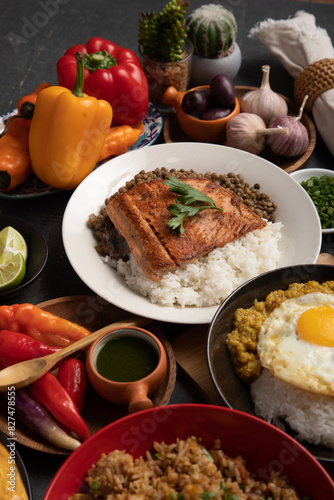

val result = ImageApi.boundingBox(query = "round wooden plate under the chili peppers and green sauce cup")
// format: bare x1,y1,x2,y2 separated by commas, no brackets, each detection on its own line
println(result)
0,295,176,455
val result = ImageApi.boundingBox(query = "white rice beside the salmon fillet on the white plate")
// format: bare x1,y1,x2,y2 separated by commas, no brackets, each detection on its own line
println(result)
110,222,283,307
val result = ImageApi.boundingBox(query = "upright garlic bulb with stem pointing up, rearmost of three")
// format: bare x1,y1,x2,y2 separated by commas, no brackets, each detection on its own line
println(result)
240,65,288,125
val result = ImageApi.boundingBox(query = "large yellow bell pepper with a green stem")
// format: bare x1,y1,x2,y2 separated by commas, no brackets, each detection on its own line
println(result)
29,52,113,189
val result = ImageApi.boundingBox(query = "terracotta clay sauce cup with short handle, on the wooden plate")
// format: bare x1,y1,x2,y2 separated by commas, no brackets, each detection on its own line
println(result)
86,327,167,413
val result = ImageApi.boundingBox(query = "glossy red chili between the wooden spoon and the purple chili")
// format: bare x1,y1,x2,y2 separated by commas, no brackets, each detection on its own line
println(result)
29,372,90,440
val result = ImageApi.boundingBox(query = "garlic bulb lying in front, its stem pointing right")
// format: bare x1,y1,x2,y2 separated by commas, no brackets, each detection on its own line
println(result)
226,113,289,155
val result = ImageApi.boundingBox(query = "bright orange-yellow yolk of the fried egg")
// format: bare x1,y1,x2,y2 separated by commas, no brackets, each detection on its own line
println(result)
297,306,334,347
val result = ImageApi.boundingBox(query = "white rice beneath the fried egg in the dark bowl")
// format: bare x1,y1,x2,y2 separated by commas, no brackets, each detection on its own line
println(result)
251,369,334,448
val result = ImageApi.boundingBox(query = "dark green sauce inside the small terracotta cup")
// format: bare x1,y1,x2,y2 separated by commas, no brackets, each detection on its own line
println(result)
96,335,159,382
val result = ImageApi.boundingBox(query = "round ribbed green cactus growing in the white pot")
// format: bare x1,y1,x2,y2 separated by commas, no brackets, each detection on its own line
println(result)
186,4,237,58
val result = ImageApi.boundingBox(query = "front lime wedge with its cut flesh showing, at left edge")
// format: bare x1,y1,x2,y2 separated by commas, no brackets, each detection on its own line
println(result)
0,250,26,292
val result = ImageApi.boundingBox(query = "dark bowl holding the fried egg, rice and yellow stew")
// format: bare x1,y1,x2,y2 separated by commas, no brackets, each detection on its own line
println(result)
207,265,334,461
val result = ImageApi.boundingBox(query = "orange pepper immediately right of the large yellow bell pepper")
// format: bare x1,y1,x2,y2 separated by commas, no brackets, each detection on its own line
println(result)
99,122,144,161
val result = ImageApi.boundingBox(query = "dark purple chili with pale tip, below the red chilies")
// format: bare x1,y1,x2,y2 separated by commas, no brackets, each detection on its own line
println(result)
11,387,81,451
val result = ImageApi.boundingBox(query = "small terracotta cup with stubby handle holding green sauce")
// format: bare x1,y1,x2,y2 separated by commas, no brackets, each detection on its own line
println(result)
86,327,167,413
